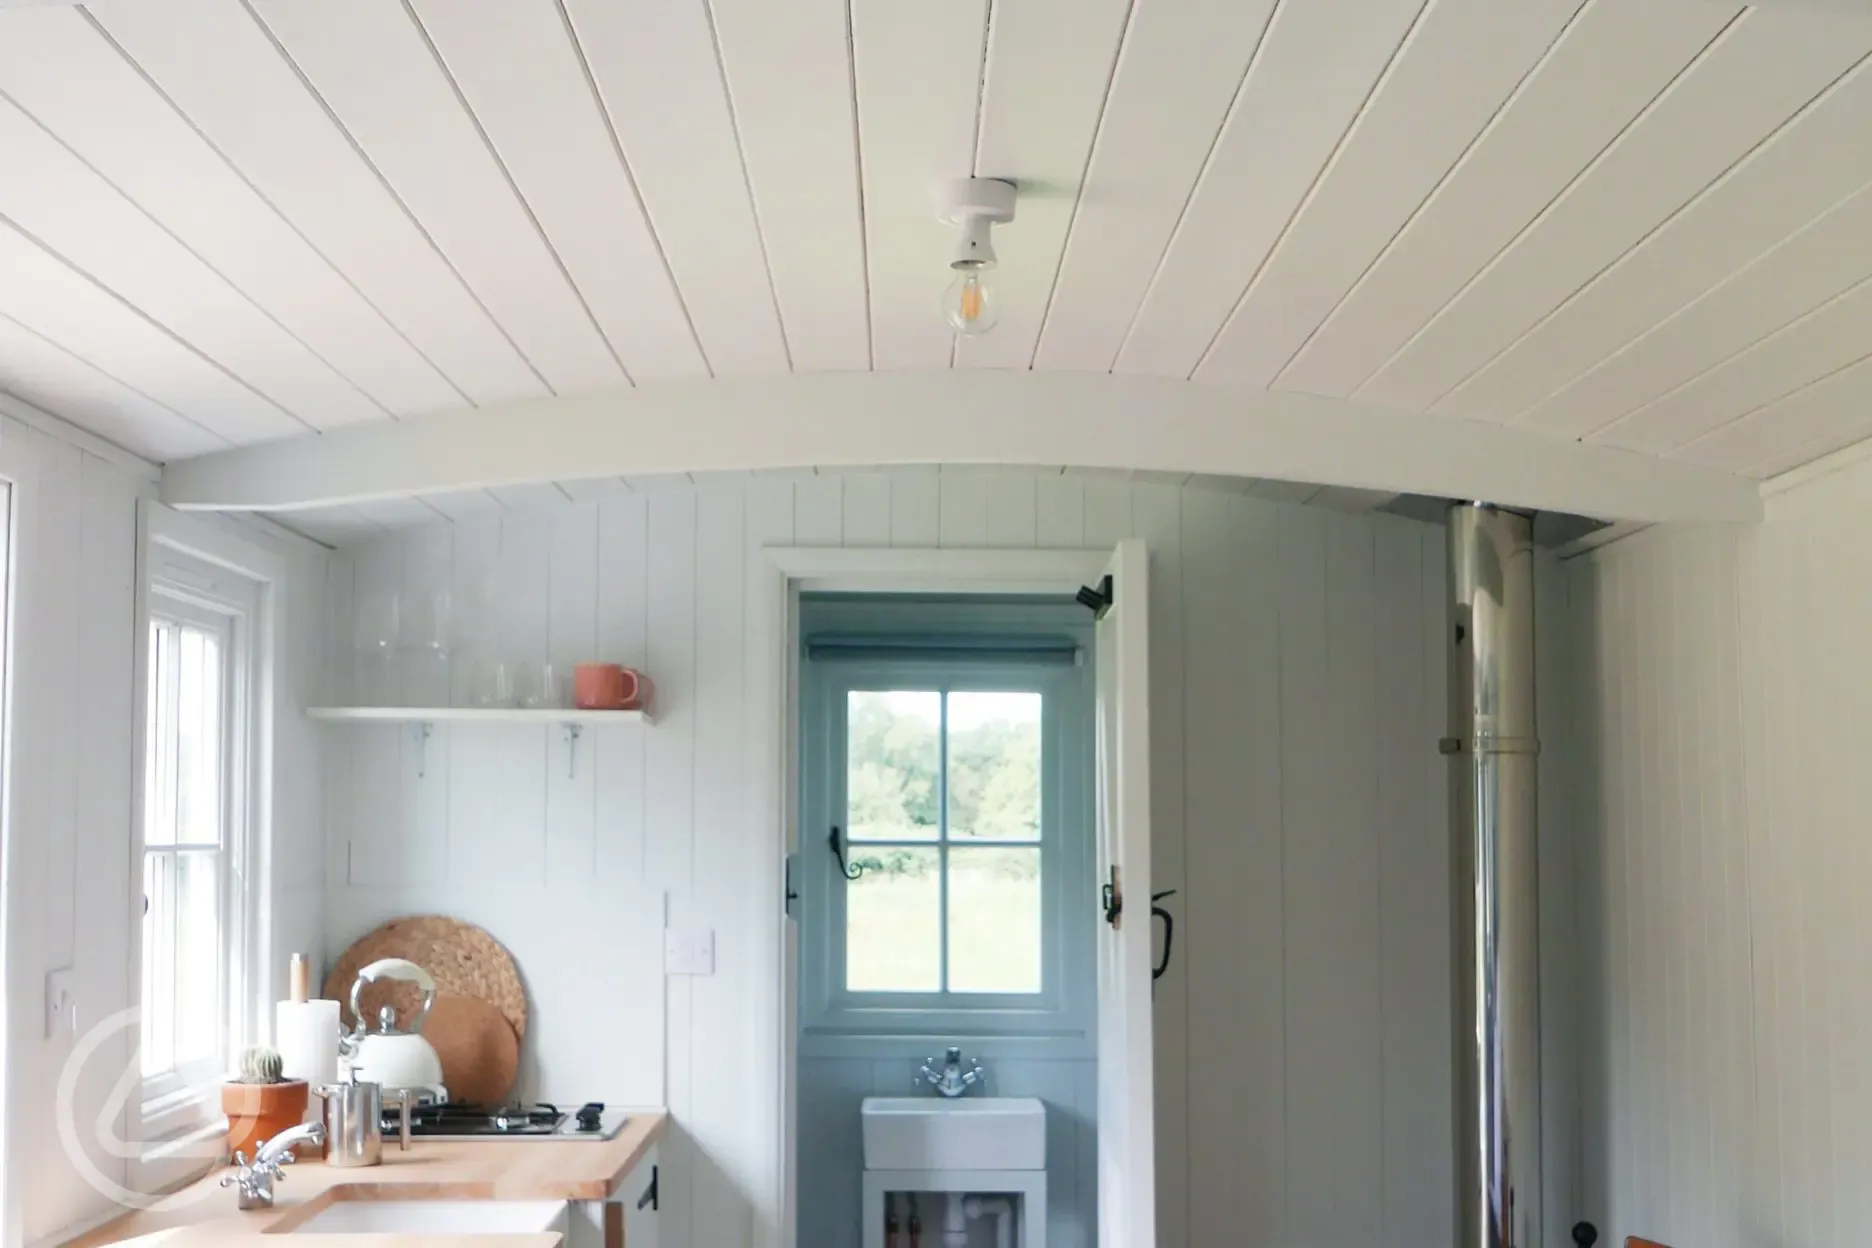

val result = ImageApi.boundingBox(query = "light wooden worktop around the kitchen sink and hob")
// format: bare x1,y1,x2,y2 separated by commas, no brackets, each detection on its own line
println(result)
67,1111,666,1248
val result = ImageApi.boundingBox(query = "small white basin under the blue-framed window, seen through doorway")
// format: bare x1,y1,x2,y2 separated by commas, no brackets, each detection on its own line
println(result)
861,1096,1046,1169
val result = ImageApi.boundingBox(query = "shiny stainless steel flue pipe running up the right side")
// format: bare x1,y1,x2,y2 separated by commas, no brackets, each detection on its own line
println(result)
1441,503,1541,1248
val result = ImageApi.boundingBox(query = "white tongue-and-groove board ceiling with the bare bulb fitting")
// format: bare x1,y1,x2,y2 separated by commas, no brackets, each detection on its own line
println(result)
0,0,1872,501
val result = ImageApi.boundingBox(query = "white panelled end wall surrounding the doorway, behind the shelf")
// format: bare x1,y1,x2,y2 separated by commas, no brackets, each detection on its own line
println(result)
326,468,1571,1248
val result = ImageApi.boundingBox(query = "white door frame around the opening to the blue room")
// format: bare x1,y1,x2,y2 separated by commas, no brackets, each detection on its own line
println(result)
747,546,1112,1248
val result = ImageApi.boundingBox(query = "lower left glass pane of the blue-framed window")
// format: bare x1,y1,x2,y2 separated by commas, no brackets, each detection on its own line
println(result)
844,846,942,992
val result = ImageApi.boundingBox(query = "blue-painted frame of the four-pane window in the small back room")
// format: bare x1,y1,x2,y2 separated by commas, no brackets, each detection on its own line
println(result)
796,649,1095,1055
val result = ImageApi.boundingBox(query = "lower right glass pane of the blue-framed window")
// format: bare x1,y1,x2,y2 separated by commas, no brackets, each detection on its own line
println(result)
949,848,1041,992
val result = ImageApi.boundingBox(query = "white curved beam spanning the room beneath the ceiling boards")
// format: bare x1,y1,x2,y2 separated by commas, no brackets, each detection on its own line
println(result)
163,370,1762,522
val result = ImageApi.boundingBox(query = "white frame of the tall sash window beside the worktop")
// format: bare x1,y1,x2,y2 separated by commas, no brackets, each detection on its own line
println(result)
125,531,270,1145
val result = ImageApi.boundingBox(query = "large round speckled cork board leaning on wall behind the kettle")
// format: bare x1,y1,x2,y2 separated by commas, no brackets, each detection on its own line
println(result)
324,915,526,1037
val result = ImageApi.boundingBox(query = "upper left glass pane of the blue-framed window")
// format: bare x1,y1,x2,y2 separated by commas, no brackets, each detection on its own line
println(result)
844,690,942,840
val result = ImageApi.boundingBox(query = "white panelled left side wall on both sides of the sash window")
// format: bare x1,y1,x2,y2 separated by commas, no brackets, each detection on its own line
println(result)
0,404,326,1242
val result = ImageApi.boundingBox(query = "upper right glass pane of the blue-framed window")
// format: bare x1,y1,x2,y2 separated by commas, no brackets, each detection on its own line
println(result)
949,692,1041,840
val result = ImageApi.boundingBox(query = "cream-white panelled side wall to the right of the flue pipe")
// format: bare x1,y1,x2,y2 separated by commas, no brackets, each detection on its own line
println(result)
1543,450,1872,1246
